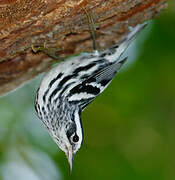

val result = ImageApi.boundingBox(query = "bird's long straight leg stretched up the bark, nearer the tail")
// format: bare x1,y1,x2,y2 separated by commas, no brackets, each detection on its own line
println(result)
83,8,97,51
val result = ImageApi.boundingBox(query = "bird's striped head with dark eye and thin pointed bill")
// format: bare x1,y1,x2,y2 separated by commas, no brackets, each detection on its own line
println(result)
48,109,83,171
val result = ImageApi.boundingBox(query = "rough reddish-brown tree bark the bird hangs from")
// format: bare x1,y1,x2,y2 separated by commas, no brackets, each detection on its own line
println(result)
0,0,166,95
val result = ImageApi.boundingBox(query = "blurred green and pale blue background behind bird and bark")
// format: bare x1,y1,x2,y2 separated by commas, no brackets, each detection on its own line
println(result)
0,0,175,180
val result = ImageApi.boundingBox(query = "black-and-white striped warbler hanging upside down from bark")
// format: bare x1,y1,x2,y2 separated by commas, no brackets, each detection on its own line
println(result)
35,10,145,169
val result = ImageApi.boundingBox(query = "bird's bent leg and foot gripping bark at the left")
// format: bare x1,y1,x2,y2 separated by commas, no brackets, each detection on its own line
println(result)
31,42,63,60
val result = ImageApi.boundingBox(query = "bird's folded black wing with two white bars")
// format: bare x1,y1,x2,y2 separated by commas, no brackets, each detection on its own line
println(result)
67,58,127,110
